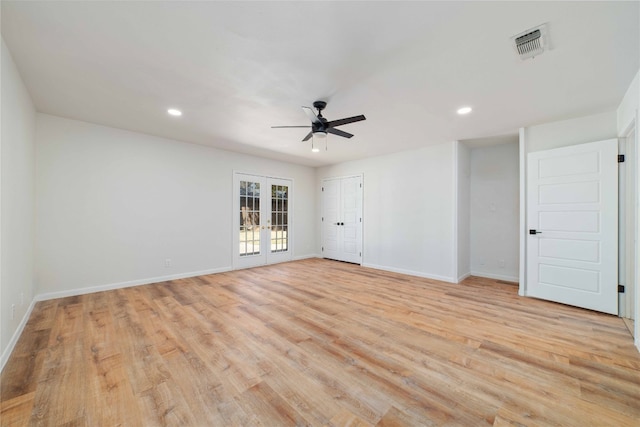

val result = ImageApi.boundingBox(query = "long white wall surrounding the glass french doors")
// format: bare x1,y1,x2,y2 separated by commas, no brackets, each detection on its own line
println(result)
36,114,317,297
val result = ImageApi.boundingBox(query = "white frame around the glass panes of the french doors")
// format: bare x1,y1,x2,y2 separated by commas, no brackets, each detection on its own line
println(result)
231,169,295,270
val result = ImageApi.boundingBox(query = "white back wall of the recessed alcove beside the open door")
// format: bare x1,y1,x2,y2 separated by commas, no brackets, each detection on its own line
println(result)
470,141,520,282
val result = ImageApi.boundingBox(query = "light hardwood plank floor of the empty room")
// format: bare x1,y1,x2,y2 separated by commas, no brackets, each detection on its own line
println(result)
1,259,640,427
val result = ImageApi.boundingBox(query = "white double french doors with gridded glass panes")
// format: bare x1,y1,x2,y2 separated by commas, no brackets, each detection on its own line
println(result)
233,173,292,269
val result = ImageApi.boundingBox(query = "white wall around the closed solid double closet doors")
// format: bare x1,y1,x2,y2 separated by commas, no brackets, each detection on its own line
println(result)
316,142,457,282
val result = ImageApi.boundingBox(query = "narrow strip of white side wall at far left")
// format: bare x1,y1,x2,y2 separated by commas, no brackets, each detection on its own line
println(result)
0,40,36,366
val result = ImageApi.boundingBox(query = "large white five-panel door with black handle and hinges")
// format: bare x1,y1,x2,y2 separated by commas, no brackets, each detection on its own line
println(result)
526,139,618,314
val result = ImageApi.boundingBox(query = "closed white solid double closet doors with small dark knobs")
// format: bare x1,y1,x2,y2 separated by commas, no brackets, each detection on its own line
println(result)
322,176,362,264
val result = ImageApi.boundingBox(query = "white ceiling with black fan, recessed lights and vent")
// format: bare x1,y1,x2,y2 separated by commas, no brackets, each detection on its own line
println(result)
1,0,640,166
